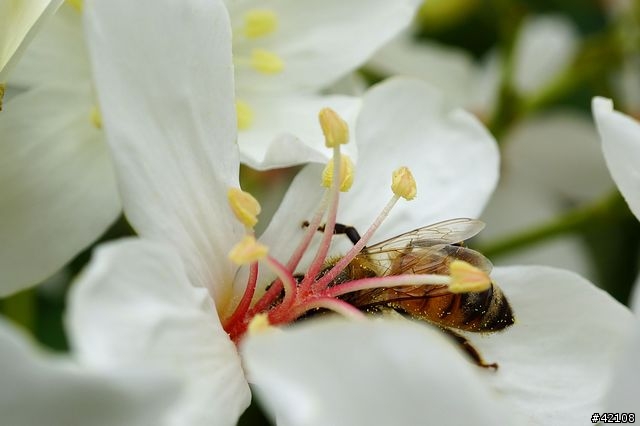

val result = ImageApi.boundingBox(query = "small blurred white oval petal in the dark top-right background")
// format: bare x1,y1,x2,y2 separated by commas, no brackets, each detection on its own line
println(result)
514,15,579,94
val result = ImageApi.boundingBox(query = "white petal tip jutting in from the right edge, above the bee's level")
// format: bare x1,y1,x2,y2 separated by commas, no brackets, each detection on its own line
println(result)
591,97,640,218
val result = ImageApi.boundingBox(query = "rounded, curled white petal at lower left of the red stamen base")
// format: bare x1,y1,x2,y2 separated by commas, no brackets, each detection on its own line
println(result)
68,239,250,425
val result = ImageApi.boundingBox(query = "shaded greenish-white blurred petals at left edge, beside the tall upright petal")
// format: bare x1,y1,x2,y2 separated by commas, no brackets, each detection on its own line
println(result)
0,2,121,296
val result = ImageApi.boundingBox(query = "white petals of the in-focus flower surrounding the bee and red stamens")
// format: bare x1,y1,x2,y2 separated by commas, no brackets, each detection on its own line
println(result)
58,0,631,425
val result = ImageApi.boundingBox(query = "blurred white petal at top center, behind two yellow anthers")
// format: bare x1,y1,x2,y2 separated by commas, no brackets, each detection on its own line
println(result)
231,0,420,94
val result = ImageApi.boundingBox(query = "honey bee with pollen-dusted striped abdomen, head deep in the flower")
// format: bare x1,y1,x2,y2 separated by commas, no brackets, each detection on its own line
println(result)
321,218,514,368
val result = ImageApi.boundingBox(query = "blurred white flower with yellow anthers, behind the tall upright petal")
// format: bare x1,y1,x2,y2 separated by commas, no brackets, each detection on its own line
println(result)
0,0,419,295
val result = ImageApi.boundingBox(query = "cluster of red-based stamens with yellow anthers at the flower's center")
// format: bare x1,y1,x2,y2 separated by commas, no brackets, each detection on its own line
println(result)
222,111,491,342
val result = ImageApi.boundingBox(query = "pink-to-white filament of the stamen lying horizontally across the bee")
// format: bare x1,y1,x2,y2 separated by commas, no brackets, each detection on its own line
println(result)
324,274,452,297
